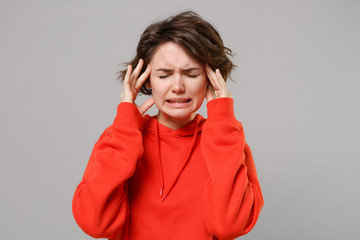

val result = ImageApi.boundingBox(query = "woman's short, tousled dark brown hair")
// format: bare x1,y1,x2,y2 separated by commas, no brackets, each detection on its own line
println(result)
118,11,235,95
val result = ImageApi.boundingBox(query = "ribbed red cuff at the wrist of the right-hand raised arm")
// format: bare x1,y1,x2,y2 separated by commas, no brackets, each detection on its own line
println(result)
206,97,236,121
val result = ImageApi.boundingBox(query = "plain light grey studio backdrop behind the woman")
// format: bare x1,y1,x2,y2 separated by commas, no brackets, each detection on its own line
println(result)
0,0,360,240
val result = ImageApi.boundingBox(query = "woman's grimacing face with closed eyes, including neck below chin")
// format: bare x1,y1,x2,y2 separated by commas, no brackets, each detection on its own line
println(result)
150,42,207,129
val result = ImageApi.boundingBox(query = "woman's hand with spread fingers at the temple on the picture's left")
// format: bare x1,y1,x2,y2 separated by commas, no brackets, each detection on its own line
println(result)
121,59,154,115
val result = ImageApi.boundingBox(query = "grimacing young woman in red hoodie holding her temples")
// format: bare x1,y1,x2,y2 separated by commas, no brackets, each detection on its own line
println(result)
73,12,263,240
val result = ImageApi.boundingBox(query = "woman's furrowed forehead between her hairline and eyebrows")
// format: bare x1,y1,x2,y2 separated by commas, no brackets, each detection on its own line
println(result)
150,42,203,69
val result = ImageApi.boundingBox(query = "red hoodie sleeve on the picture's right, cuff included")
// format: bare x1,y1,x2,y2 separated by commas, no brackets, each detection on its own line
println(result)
201,98,264,239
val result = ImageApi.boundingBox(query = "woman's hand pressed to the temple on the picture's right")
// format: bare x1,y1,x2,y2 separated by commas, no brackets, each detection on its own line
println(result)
205,64,231,102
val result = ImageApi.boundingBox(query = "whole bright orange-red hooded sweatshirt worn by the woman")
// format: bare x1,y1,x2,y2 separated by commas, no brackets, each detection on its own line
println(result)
72,98,263,240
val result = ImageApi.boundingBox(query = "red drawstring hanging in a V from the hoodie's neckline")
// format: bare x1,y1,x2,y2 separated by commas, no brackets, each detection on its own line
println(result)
155,119,199,201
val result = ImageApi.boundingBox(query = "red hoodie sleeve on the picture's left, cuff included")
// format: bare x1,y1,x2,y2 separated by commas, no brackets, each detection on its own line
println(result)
72,103,143,238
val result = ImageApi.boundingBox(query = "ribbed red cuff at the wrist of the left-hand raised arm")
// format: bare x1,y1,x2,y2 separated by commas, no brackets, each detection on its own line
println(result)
114,102,142,129
